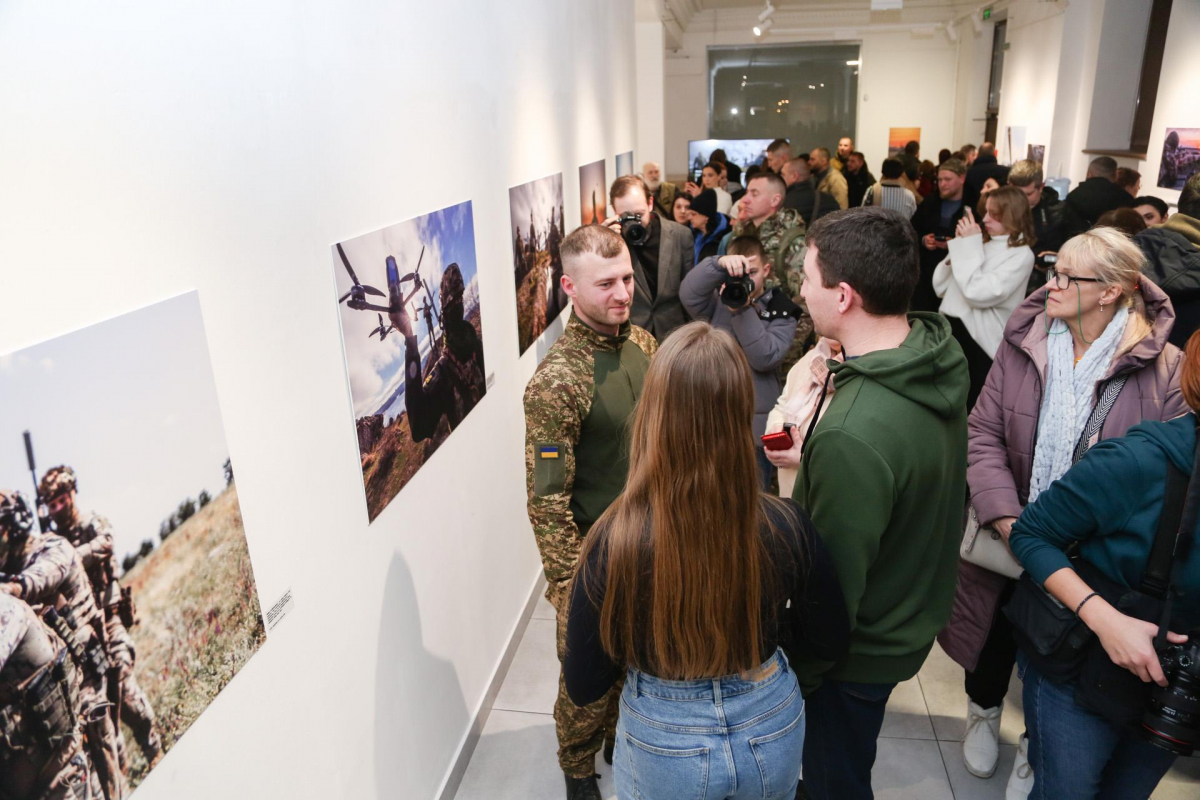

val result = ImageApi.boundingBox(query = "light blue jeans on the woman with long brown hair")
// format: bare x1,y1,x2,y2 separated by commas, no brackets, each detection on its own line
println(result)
612,650,804,800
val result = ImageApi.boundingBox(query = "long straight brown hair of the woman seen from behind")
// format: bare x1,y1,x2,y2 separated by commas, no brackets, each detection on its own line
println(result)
575,321,787,680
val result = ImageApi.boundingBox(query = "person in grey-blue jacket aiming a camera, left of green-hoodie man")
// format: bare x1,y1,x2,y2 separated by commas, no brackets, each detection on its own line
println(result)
679,236,802,489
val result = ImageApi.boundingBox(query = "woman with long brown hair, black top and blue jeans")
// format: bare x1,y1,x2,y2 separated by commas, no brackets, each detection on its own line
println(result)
563,323,850,800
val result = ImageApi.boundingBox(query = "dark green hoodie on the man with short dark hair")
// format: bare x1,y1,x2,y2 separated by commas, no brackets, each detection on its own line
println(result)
788,313,970,691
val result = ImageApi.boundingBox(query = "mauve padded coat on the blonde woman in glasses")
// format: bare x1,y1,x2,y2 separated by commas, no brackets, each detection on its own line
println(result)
937,277,1188,670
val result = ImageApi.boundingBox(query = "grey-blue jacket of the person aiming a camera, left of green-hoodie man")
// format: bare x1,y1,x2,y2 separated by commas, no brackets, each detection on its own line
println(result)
679,257,799,437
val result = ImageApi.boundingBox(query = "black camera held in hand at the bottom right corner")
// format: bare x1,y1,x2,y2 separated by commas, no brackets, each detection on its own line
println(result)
1141,639,1200,756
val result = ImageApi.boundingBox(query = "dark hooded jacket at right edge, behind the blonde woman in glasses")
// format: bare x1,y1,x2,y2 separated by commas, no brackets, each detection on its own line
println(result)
1133,213,1200,349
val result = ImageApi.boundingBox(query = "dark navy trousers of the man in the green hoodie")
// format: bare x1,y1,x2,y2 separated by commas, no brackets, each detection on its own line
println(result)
804,678,896,800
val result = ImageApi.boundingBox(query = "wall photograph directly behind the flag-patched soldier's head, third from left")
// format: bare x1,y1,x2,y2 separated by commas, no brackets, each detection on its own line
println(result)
509,173,566,354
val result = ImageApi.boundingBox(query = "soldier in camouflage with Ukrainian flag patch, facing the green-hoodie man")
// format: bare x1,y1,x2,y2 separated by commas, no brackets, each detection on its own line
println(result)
524,225,658,800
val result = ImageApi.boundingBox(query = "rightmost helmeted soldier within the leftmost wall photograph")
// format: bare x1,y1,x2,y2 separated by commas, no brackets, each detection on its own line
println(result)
38,467,162,772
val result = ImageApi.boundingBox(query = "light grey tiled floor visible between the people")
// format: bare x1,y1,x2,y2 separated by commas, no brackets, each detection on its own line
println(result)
456,600,1200,800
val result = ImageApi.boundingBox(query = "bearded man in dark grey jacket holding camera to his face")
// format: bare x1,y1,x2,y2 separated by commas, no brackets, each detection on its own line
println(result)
604,175,695,342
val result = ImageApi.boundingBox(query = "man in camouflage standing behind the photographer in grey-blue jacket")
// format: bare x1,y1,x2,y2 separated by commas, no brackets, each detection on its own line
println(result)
731,175,812,375
